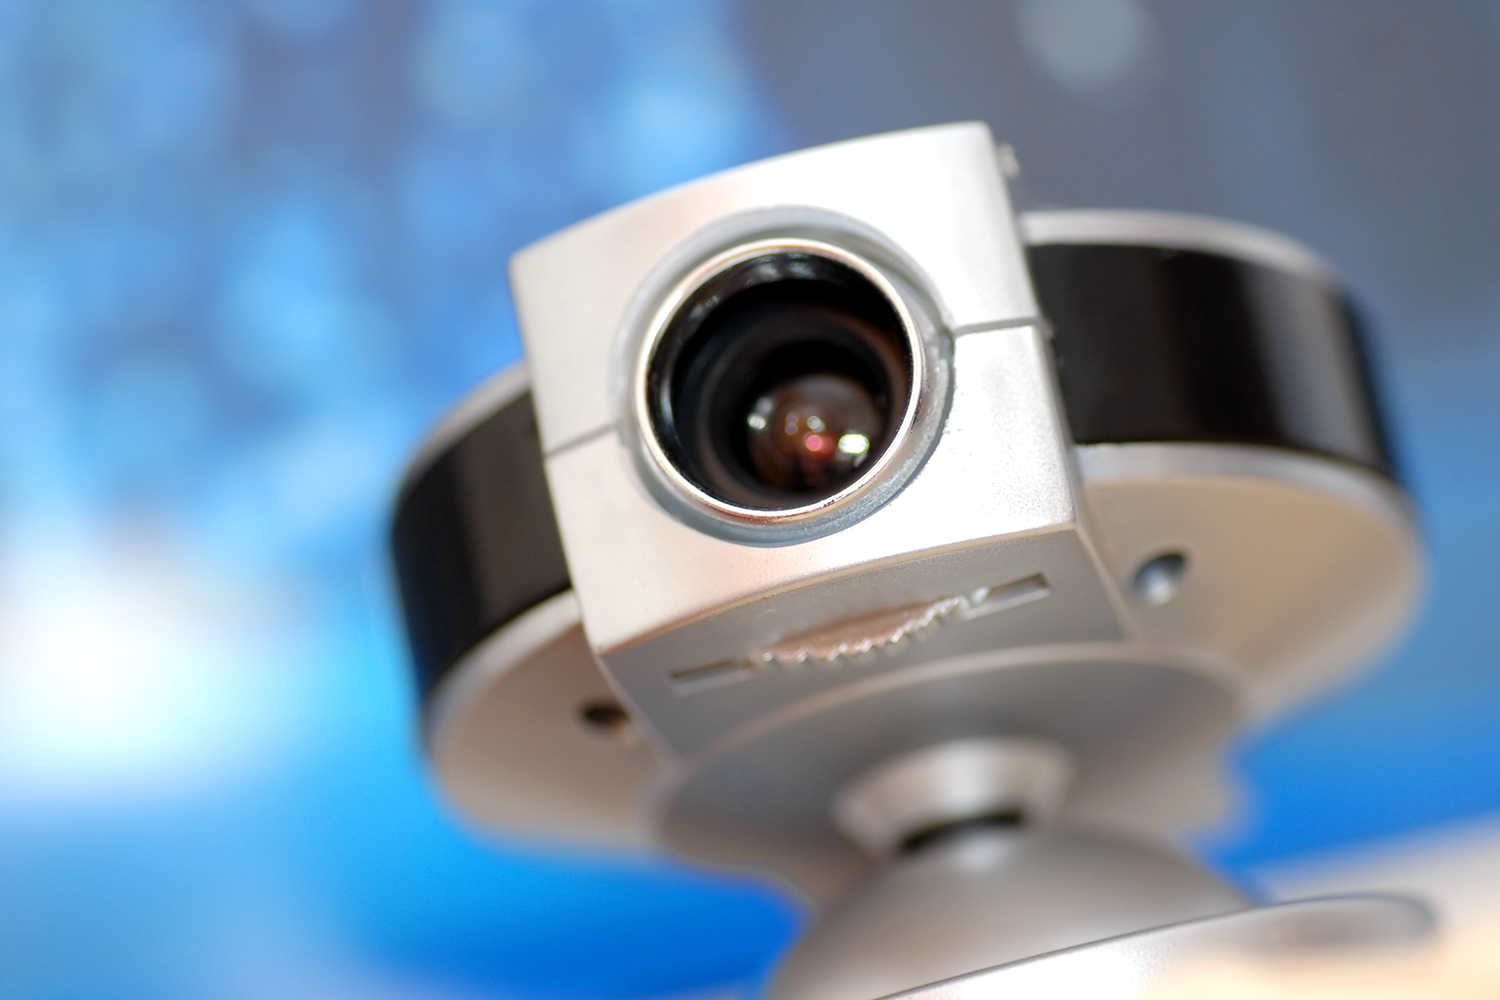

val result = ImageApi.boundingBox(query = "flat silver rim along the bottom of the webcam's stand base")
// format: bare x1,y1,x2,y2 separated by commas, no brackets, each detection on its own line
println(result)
893,895,1434,1000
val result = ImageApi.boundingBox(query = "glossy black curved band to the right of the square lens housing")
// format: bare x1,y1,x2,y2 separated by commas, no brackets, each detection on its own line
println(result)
1028,244,1394,475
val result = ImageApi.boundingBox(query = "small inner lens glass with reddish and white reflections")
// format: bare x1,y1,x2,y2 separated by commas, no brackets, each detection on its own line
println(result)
746,373,885,493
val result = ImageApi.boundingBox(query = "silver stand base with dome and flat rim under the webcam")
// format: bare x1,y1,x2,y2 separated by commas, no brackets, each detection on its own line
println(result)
771,826,1431,1000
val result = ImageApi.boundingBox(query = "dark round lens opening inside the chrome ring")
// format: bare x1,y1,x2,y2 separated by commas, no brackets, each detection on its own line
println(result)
647,249,915,511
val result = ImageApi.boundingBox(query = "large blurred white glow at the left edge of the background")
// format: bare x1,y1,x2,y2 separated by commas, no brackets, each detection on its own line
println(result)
0,521,296,799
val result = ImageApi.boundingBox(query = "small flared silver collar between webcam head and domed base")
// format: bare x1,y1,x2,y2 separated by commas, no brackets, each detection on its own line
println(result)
831,736,1074,858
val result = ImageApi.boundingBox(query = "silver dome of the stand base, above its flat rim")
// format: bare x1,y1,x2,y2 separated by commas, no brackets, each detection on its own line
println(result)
771,829,1250,1000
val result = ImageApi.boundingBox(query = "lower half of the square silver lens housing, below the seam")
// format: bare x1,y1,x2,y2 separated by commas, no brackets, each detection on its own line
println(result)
548,327,1104,756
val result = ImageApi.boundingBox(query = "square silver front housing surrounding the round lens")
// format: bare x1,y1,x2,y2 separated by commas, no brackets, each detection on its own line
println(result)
513,126,1122,756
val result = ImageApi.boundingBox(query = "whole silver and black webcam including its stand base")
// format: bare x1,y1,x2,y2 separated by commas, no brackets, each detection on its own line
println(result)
392,123,1430,1000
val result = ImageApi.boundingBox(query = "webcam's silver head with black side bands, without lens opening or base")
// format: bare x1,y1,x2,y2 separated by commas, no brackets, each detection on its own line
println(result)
396,124,1421,996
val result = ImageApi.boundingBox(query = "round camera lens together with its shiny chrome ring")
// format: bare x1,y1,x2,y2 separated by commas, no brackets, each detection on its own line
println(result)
633,238,930,529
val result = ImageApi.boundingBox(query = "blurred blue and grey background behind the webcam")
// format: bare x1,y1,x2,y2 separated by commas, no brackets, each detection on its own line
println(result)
0,0,1500,1000
